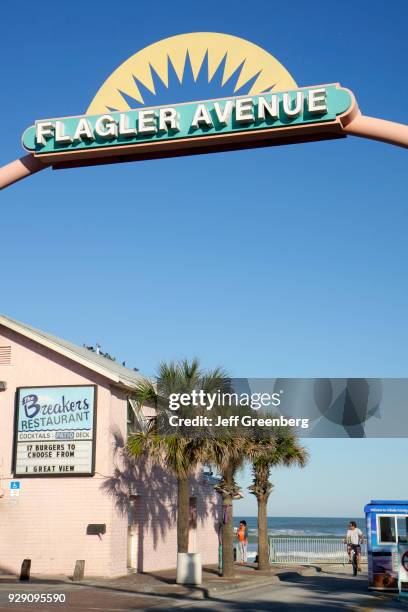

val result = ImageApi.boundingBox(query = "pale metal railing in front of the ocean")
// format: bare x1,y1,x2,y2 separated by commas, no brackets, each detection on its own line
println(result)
269,536,367,565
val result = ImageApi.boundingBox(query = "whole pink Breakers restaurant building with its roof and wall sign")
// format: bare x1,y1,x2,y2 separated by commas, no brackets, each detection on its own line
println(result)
0,316,220,576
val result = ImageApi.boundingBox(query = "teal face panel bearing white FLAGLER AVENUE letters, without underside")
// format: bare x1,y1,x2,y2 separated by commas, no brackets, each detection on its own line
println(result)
23,84,353,156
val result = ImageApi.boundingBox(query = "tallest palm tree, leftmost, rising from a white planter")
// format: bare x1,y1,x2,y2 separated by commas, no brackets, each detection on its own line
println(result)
126,359,226,553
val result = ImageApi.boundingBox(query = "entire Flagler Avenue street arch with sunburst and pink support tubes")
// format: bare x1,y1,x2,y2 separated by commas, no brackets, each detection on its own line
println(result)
0,32,408,188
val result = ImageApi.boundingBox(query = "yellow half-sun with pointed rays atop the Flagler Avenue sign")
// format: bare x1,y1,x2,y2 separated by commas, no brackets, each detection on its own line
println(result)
87,32,297,115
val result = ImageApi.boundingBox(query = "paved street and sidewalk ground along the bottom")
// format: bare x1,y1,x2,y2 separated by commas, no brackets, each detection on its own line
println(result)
0,564,408,612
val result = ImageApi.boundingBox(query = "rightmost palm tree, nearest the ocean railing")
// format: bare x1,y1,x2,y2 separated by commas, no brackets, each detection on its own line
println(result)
247,427,309,570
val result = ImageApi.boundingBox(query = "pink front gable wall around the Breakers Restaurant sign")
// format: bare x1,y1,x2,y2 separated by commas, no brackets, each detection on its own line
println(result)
0,326,127,576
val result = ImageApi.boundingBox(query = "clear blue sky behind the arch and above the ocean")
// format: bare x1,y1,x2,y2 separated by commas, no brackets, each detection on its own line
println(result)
0,0,408,516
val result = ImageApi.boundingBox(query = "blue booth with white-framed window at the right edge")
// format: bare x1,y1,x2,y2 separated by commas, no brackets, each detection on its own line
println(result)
364,499,408,591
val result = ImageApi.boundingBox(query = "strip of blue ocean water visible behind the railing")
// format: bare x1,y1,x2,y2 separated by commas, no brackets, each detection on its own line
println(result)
234,516,365,558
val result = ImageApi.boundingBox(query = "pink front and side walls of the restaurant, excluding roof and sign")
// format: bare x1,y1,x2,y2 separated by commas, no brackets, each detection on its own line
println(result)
0,325,220,576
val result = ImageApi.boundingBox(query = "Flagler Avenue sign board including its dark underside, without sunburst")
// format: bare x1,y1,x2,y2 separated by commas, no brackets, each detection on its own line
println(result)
23,84,355,165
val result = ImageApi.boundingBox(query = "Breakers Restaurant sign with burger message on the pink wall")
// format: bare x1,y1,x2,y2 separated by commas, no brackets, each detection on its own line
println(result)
14,385,96,476
